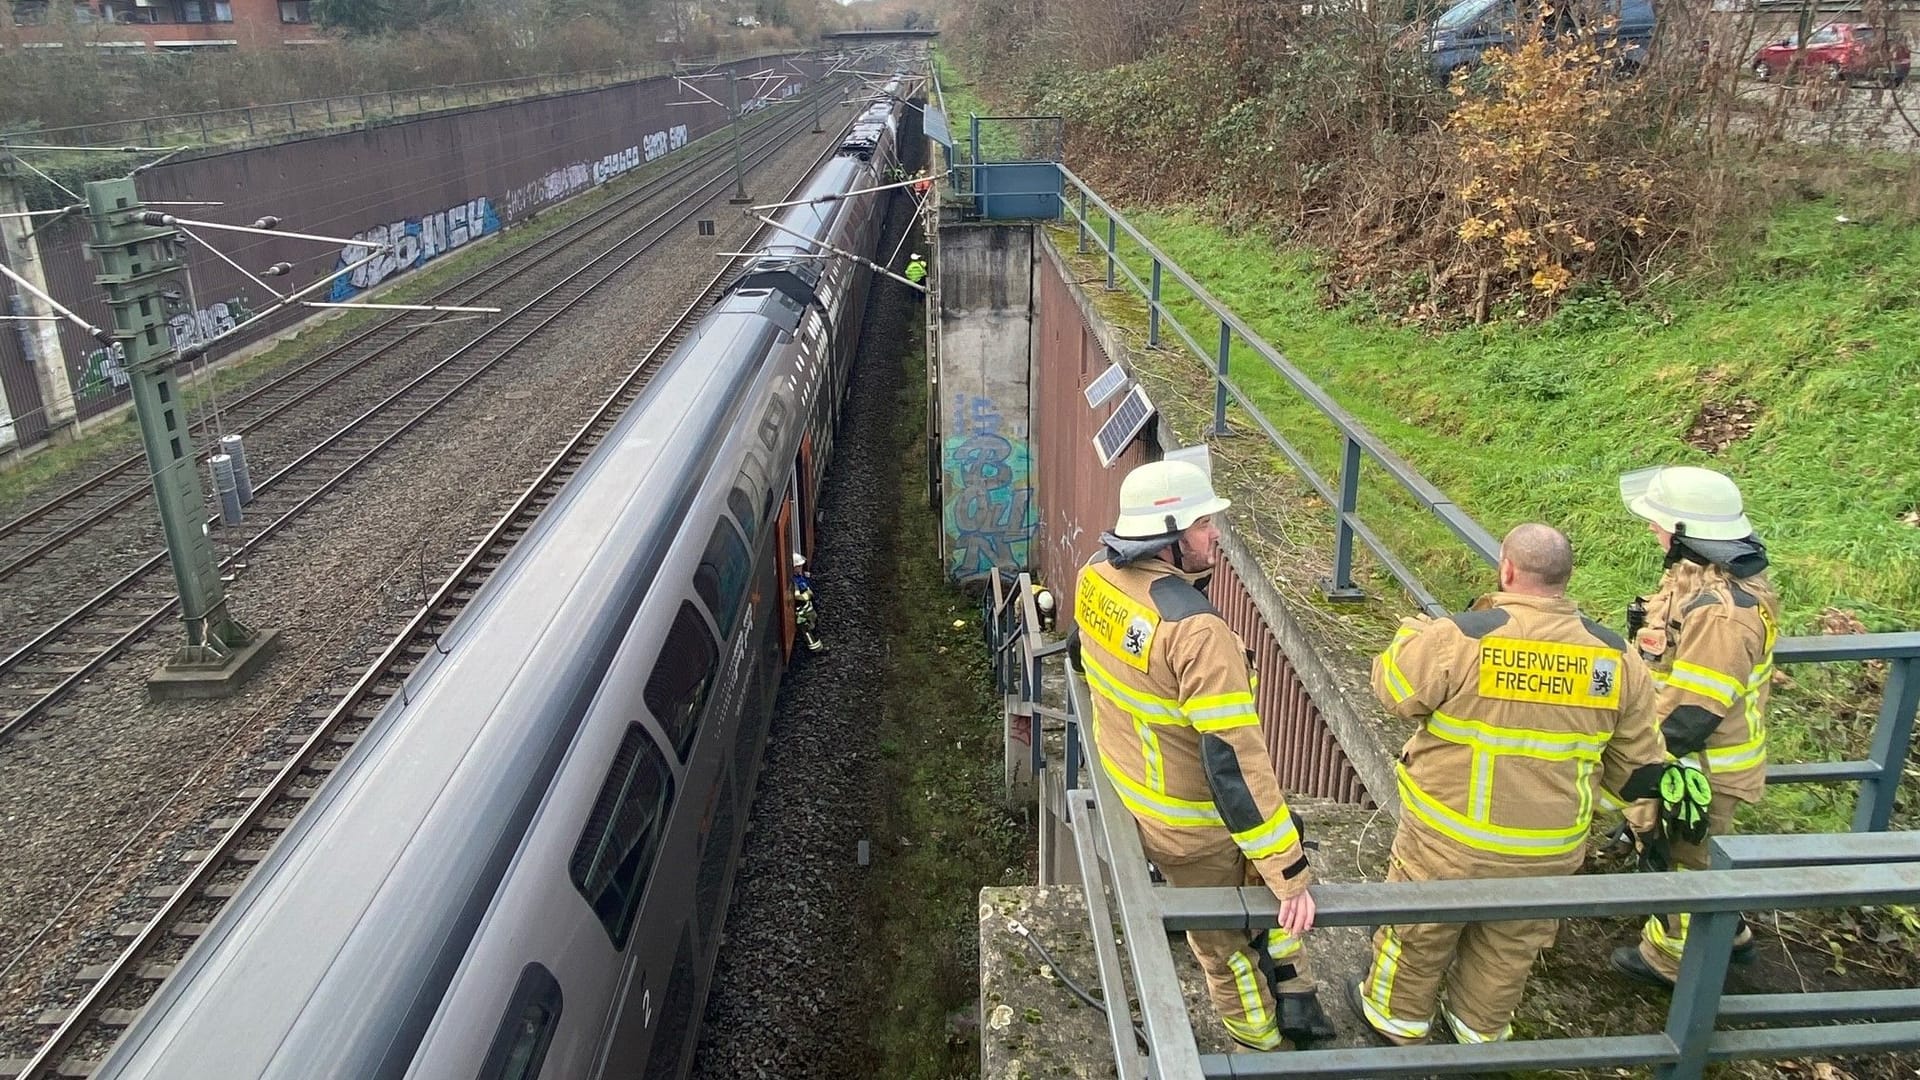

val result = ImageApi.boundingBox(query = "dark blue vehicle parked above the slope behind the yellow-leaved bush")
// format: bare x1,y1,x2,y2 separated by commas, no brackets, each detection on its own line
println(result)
1425,0,1653,83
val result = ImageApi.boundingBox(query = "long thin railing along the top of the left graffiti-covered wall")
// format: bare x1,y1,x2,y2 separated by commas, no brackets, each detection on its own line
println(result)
0,50,795,150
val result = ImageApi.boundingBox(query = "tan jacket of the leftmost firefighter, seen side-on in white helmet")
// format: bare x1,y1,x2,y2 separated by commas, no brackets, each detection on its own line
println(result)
1073,552,1309,899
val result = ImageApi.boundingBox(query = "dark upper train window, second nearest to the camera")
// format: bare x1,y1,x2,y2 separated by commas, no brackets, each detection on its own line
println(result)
566,724,674,949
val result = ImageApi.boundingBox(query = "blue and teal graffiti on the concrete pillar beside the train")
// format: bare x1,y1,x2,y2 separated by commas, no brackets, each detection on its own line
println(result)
941,394,1035,580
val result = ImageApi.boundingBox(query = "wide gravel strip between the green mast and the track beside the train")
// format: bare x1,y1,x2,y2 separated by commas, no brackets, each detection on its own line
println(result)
0,117,856,1057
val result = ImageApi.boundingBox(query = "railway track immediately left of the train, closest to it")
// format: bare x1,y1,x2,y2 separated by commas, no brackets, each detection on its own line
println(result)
0,105,860,1080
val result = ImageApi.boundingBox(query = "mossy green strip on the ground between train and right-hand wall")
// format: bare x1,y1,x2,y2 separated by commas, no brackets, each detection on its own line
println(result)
862,307,1031,1080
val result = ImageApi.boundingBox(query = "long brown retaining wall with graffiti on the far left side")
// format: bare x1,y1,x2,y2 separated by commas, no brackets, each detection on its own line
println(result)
16,58,816,426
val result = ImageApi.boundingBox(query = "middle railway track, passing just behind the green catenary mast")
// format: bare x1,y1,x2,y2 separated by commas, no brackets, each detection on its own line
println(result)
0,96,840,740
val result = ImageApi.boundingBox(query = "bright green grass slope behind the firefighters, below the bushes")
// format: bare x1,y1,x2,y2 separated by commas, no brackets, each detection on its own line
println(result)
1058,202,1920,828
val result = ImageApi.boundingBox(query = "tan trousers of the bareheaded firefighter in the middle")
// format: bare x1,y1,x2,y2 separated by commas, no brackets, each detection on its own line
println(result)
1359,830,1571,1043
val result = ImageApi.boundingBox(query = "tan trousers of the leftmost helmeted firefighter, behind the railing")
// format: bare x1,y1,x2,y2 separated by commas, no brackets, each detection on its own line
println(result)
1140,822,1313,1049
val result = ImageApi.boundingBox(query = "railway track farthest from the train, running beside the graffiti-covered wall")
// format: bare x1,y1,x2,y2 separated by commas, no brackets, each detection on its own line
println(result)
0,86,837,584
